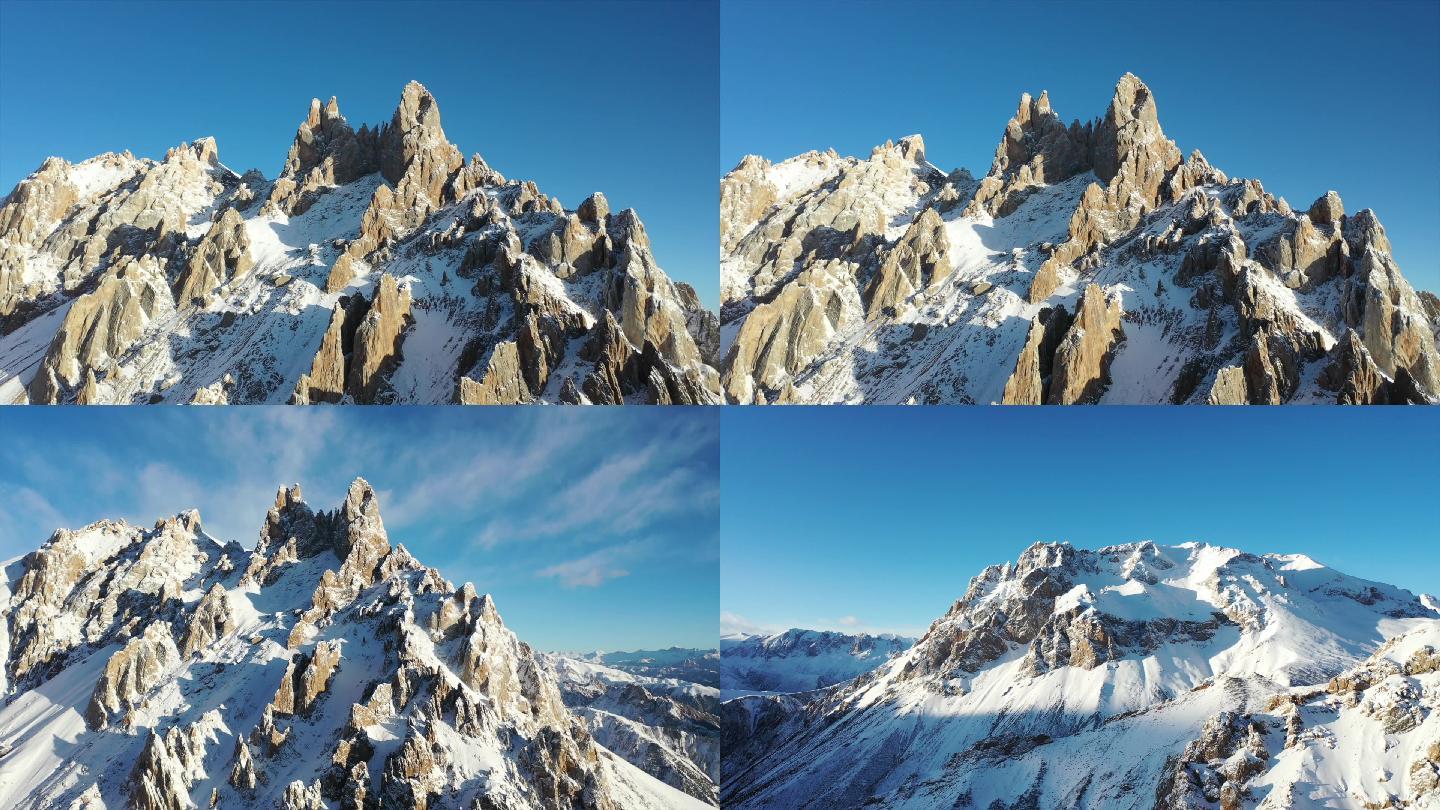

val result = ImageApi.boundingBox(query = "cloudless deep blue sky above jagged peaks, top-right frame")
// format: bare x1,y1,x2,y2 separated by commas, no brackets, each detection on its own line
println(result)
719,0,1440,291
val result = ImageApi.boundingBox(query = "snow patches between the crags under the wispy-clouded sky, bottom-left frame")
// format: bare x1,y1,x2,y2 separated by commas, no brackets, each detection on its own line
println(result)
0,530,706,810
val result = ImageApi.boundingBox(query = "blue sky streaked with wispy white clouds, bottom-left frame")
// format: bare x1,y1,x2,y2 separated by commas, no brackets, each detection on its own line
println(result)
0,406,720,650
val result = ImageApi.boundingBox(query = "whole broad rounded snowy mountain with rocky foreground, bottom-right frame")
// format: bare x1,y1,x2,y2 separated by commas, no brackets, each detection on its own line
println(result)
721,542,1440,810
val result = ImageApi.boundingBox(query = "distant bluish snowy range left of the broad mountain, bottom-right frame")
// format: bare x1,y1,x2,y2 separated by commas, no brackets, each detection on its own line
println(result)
720,628,914,698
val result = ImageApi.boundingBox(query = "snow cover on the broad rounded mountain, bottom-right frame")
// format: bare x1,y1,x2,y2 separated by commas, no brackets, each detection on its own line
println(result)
721,543,1440,810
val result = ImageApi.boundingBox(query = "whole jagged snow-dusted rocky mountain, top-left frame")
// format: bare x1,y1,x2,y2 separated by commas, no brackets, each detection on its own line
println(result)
0,82,720,404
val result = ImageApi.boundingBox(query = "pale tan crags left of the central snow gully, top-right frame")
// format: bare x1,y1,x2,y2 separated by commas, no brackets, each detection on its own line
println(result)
720,135,946,404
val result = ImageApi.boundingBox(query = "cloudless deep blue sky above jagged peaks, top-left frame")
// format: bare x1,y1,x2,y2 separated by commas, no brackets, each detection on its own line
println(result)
0,0,719,307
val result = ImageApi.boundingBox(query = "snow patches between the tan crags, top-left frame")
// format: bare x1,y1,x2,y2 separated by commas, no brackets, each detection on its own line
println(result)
0,149,684,404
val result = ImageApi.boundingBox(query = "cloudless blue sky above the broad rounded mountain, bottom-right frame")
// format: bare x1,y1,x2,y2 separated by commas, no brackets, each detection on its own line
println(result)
720,406,1440,634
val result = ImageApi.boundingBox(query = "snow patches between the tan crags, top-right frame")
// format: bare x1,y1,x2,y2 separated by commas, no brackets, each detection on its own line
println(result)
720,141,1428,404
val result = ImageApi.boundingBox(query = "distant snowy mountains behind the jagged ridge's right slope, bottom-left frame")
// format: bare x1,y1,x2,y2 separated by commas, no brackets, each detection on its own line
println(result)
544,647,720,804
